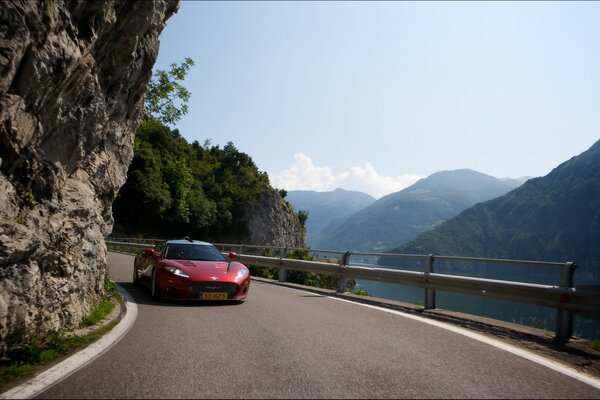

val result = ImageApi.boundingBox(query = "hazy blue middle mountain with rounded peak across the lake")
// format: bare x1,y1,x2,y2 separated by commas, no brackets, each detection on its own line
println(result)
315,169,518,251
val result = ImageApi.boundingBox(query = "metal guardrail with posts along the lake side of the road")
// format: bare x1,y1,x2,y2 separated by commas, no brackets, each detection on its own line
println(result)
106,238,600,341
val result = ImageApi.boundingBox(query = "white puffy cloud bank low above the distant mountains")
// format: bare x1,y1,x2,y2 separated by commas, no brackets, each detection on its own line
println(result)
271,153,422,198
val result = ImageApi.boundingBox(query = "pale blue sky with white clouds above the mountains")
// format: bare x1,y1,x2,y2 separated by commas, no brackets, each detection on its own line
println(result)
155,1,600,197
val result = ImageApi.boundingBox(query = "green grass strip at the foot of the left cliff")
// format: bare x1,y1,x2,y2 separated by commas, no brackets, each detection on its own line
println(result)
0,273,121,390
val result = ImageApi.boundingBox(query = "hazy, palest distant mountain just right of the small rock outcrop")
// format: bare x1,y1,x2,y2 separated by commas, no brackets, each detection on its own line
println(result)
286,189,375,247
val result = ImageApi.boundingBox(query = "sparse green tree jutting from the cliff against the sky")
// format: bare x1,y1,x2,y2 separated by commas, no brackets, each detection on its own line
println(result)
144,57,194,125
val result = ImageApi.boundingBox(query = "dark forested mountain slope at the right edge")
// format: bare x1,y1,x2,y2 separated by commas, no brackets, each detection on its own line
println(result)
390,141,600,282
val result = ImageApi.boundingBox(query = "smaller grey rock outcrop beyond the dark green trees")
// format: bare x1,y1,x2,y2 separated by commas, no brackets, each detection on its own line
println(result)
241,189,305,248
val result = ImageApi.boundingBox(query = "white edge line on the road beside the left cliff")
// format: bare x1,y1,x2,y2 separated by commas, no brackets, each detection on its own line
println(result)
0,285,137,399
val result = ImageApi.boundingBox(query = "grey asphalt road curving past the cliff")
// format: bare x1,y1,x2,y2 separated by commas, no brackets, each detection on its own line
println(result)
38,253,600,398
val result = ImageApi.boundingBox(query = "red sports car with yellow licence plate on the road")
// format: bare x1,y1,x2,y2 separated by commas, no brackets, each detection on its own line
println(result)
133,238,250,302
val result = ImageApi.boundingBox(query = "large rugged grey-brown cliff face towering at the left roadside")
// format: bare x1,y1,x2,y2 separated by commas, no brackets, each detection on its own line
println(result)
0,0,178,355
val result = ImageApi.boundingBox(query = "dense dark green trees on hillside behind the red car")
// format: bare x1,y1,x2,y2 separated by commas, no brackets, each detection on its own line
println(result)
113,117,270,240
